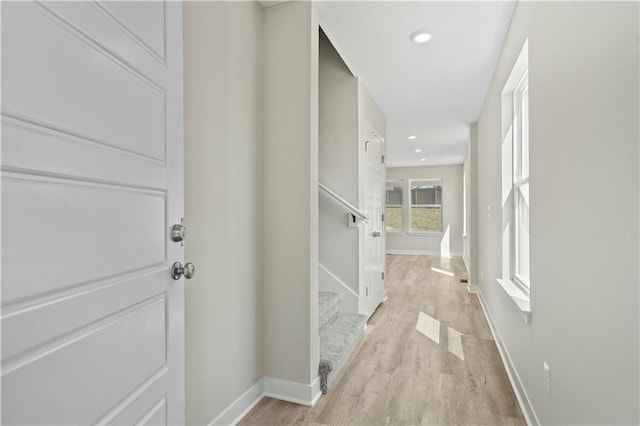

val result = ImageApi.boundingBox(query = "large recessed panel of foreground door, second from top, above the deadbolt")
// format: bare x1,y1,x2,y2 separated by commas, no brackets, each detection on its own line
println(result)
2,2,166,161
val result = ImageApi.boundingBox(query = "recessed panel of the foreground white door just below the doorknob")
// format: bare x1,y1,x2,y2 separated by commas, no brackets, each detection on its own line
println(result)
2,295,166,424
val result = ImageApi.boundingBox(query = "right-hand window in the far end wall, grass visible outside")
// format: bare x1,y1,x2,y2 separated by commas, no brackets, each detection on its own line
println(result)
409,179,442,232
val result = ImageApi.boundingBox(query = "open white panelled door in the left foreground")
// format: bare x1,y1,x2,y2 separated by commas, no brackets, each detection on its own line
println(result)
2,1,184,424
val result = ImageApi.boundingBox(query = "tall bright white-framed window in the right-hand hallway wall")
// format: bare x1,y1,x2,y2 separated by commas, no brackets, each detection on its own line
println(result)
511,72,529,288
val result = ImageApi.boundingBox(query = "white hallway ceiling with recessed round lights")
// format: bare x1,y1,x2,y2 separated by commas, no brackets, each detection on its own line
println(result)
318,1,515,167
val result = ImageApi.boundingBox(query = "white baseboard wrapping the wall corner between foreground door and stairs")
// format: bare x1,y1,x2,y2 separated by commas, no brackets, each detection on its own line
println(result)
210,377,322,426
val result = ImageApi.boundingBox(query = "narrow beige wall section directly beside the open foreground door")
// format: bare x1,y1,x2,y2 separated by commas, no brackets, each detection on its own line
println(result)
184,2,263,424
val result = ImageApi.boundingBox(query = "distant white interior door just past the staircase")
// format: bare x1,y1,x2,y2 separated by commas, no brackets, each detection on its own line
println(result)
361,138,385,316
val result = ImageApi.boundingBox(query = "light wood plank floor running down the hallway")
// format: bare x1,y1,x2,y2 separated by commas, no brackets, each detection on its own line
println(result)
239,255,525,425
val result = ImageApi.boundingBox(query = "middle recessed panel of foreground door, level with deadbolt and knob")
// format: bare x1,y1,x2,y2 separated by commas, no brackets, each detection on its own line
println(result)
2,173,167,303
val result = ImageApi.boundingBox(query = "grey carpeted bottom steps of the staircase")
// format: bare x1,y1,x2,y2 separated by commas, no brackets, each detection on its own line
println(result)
319,292,367,394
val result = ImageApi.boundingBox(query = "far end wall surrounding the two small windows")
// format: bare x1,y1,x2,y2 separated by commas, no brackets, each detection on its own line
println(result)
386,164,463,256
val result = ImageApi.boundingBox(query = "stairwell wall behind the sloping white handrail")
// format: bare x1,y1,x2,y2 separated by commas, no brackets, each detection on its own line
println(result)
318,28,359,306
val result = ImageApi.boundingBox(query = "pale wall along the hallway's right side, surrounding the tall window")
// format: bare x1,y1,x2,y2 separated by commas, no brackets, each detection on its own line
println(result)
472,2,640,424
